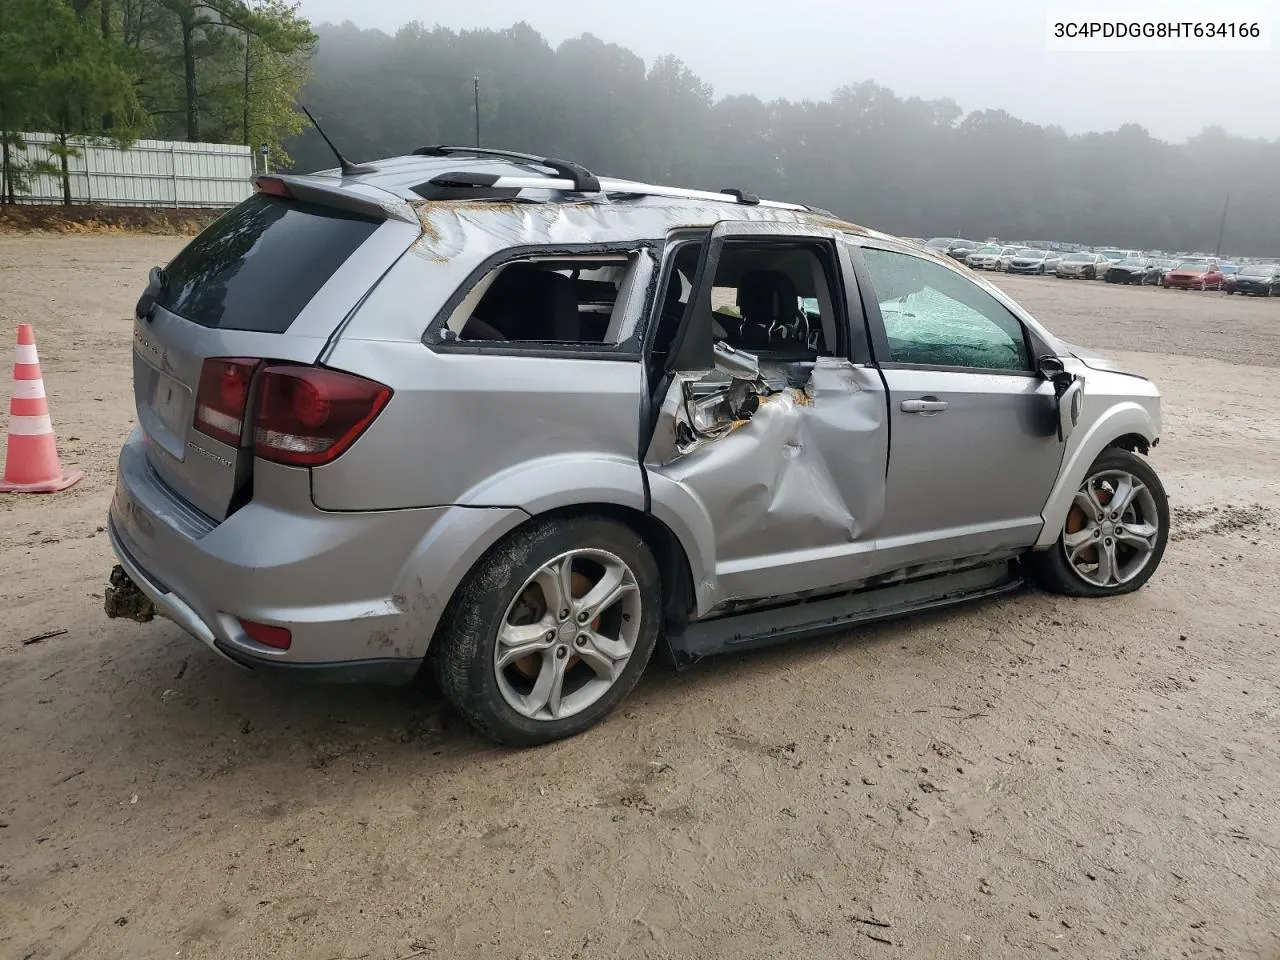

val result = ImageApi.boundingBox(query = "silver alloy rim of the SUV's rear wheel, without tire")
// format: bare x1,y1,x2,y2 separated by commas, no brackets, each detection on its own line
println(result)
493,548,641,721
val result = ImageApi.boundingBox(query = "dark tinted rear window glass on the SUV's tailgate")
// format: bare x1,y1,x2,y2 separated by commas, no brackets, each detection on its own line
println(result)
160,193,381,333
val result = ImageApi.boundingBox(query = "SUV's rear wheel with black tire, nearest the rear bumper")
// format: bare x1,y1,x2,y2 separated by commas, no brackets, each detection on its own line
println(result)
431,513,662,746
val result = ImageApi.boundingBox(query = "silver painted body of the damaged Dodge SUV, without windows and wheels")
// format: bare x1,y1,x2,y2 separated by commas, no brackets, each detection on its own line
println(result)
109,156,1160,680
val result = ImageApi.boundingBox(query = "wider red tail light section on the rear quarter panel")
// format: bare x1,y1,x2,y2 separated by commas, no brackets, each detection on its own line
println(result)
253,364,392,467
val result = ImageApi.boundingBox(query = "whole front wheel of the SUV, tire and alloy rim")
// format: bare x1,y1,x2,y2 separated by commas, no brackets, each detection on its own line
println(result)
1027,447,1169,596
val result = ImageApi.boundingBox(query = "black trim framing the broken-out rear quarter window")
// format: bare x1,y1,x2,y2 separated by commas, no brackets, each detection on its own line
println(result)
422,239,663,362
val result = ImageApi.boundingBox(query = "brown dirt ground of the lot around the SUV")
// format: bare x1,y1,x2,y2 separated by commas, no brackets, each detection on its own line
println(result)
0,234,1280,960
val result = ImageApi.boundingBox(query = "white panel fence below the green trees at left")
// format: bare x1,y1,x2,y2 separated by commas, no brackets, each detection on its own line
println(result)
6,133,256,207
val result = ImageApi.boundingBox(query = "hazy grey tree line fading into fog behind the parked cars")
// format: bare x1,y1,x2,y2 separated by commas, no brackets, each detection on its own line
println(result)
288,23,1280,256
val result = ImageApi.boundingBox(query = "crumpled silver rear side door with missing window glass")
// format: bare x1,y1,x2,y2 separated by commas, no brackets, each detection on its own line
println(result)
644,224,887,614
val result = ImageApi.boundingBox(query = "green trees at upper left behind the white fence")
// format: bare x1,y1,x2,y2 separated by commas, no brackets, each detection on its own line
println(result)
0,0,315,204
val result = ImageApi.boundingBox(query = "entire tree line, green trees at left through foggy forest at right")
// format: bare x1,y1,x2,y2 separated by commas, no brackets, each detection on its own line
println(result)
0,9,1280,256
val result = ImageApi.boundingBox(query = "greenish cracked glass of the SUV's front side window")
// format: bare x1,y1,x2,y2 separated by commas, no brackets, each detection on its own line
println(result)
863,247,1030,371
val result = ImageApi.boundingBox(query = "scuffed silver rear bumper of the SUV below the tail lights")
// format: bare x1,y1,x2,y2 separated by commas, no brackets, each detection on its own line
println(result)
108,430,527,681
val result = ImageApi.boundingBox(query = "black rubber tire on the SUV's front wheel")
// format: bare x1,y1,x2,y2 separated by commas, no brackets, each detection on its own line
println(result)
1025,447,1169,596
